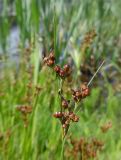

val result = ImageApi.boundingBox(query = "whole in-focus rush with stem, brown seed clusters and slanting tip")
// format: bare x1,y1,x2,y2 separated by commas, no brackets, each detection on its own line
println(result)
43,51,104,159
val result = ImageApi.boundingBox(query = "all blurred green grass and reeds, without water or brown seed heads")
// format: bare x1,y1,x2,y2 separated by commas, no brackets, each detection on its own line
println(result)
0,0,121,160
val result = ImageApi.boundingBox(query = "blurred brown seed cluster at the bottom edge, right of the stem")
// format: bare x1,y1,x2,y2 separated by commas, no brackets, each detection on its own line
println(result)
68,138,104,160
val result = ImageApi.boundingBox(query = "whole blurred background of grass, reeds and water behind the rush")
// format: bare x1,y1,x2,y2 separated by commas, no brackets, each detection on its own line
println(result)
0,0,121,160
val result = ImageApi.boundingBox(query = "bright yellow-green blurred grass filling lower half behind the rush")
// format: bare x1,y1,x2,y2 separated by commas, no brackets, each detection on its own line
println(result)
0,57,121,160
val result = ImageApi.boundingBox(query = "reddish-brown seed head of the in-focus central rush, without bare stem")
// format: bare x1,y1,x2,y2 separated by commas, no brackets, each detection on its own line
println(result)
44,52,90,136
